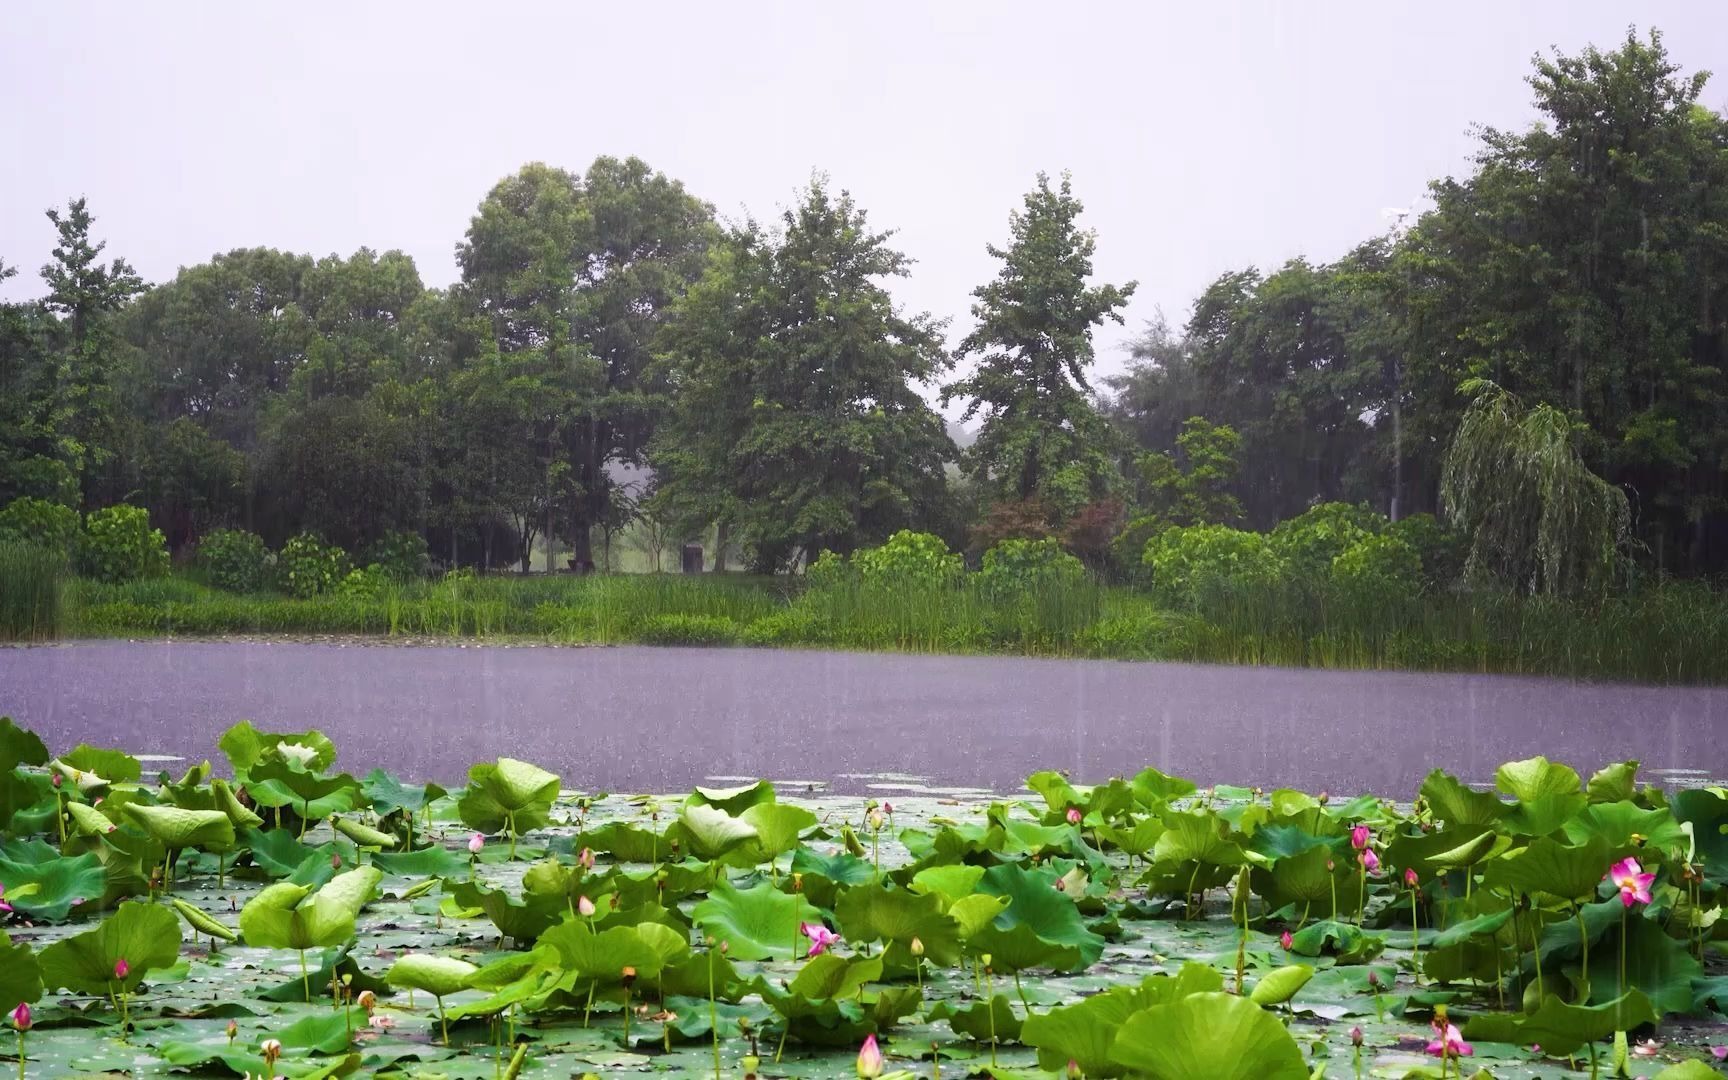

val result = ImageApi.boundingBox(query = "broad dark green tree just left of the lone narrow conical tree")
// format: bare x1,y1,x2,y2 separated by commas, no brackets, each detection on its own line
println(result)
651,180,956,569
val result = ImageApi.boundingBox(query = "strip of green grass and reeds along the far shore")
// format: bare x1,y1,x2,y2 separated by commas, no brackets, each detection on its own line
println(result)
43,575,1728,683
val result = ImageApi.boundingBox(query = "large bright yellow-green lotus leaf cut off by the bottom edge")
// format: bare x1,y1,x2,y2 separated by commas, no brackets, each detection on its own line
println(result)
1109,994,1308,1080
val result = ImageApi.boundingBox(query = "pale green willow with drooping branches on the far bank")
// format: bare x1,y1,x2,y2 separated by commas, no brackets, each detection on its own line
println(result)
1439,378,1631,594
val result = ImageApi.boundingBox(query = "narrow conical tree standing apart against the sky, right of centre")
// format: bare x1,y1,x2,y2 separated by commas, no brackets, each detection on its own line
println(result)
942,173,1134,518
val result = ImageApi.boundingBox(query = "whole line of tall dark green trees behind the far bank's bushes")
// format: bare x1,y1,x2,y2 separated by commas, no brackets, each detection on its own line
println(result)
0,33,1728,575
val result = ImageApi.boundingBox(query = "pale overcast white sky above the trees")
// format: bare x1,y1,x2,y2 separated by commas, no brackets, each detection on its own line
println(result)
0,0,1728,381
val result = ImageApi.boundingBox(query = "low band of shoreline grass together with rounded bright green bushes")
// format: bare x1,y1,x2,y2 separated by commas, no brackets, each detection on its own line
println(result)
0,503,1728,684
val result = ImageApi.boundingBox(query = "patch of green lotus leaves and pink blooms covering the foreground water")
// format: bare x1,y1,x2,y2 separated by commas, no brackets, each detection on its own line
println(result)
0,721,1728,1080
